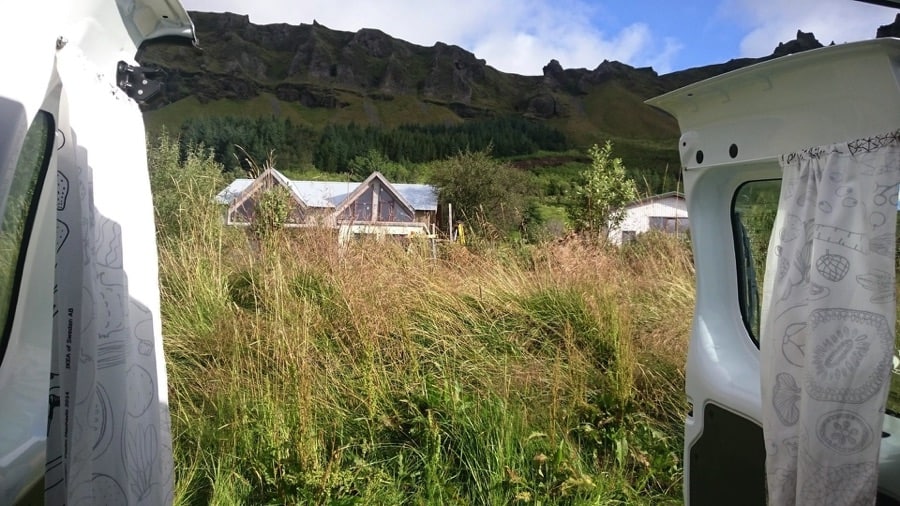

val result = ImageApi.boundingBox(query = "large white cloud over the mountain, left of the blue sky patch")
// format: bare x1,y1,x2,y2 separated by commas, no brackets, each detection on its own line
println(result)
178,0,682,75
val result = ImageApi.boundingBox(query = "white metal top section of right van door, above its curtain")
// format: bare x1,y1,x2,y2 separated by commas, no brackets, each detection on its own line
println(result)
647,39,900,171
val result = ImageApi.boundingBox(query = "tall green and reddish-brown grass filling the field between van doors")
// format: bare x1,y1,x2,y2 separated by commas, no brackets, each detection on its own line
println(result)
151,139,693,504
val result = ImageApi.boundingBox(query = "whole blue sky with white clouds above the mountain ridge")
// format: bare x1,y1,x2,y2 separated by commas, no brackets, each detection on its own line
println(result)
182,0,900,75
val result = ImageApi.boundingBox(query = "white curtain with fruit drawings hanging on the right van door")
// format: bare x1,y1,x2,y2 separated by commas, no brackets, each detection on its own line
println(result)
760,130,900,506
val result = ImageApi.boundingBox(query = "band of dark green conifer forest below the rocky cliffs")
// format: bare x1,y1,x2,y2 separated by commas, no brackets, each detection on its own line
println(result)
180,116,569,176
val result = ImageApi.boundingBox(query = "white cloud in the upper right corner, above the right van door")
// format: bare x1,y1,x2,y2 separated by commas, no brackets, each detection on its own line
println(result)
725,0,897,57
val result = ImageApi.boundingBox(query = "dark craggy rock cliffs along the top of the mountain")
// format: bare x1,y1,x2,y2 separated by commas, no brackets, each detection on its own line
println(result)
139,12,884,126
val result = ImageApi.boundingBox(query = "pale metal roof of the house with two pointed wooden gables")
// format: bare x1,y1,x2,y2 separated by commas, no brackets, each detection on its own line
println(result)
216,173,437,211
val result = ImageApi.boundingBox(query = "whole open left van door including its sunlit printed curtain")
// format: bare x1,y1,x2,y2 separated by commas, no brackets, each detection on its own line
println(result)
0,0,193,504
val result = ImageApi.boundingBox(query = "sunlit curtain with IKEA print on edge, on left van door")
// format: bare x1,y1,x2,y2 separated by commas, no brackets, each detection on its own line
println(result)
44,47,172,506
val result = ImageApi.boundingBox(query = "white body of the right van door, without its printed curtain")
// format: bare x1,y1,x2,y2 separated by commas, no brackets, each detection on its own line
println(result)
648,39,900,505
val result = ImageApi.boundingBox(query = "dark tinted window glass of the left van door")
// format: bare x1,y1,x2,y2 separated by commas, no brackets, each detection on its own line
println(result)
0,112,55,357
